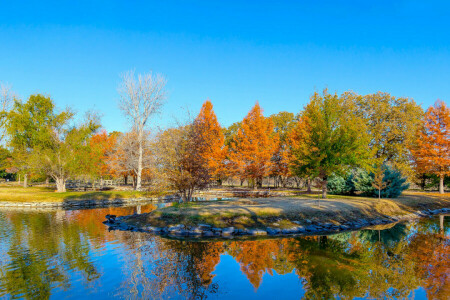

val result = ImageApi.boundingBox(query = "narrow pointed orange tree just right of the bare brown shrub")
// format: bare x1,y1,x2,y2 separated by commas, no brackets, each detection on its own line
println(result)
194,100,228,184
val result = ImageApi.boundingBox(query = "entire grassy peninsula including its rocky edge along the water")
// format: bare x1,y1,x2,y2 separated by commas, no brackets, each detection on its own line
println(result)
103,195,450,239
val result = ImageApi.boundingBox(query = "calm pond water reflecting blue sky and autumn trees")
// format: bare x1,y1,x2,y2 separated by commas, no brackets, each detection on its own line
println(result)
0,205,450,300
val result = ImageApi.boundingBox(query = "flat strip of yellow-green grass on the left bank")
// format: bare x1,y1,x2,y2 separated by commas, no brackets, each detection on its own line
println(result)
0,186,163,202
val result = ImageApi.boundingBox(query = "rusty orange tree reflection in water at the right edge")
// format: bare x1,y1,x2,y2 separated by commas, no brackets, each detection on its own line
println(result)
409,232,450,299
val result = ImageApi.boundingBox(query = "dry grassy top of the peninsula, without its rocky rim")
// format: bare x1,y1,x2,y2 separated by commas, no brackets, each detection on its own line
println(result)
122,192,450,229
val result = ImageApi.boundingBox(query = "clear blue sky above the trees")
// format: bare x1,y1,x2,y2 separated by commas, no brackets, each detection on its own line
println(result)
0,0,450,131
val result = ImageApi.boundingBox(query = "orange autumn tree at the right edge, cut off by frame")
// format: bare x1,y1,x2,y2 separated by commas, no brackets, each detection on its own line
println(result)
411,100,450,194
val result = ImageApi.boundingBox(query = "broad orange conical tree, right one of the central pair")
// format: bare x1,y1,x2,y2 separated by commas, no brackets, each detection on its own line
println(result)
229,102,278,189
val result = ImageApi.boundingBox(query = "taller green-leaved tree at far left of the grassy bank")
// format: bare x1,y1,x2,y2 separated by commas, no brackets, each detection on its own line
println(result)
6,94,73,187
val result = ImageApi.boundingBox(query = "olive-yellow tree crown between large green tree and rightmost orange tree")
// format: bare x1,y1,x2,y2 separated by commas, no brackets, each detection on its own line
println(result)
354,92,423,176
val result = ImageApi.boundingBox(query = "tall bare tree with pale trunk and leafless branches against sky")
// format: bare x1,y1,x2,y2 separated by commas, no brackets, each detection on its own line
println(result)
119,71,166,190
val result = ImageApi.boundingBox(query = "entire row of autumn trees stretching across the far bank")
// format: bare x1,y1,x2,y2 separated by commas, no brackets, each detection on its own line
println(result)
0,72,450,200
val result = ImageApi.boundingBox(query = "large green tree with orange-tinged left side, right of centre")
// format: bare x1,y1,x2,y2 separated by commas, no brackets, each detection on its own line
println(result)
293,90,370,198
